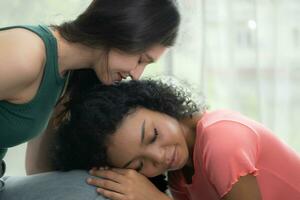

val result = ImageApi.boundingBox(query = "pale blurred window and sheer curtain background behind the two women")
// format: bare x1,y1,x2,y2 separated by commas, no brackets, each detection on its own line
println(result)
0,0,300,175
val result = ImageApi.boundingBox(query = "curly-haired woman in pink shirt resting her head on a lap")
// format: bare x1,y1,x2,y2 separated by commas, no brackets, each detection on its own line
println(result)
45,80,300,200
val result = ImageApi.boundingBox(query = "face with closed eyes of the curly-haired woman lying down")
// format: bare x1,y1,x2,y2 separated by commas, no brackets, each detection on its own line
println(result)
107,108,189,177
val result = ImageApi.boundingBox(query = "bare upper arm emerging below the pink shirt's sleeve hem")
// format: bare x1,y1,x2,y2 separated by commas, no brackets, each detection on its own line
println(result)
222,175,262,200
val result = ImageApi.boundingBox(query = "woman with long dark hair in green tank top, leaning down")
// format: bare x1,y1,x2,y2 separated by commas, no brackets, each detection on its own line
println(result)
0,0,180,198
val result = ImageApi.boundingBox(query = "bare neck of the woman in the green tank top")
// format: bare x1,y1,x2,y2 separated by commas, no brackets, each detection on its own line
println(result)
52,30,100,76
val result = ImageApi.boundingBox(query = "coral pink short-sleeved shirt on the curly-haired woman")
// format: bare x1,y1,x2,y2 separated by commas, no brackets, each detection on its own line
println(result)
168,110,300,200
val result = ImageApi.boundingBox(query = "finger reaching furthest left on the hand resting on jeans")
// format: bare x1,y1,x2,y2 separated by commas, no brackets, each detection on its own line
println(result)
87,178,125,194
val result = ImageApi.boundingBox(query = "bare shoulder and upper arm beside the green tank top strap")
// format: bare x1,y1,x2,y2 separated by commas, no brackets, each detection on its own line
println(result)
0,28,45,99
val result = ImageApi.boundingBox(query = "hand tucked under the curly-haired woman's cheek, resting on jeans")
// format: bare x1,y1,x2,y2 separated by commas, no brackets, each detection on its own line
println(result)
87,169,170,200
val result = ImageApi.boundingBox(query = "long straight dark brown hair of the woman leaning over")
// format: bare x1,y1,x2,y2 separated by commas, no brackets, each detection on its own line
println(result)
54,0,180,125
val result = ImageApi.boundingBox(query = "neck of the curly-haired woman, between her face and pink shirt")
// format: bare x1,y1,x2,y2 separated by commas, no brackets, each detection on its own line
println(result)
181,113,202,166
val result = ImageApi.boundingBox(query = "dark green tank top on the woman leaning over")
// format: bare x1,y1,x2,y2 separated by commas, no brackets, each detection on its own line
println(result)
0,26,66,159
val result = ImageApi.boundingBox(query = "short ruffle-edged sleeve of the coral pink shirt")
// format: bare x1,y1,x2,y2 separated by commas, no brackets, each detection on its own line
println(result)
201,120,259,197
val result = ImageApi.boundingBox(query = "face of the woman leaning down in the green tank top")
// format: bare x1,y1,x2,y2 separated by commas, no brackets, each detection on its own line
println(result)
94,45,166,85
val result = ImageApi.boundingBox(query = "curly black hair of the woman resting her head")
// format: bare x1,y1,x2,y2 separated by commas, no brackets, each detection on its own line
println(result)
53,79,204,192
